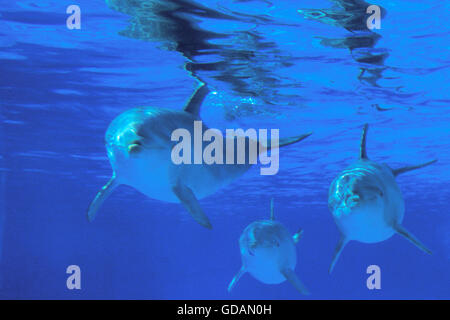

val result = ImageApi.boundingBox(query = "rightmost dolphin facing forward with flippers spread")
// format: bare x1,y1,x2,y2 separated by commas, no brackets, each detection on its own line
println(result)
328,124,437,273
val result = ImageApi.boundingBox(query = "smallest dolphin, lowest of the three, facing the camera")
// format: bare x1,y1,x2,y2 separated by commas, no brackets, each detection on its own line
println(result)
228,199,309,294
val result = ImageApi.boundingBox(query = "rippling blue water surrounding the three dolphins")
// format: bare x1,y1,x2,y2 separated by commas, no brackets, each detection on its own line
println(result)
0,0,450,299
